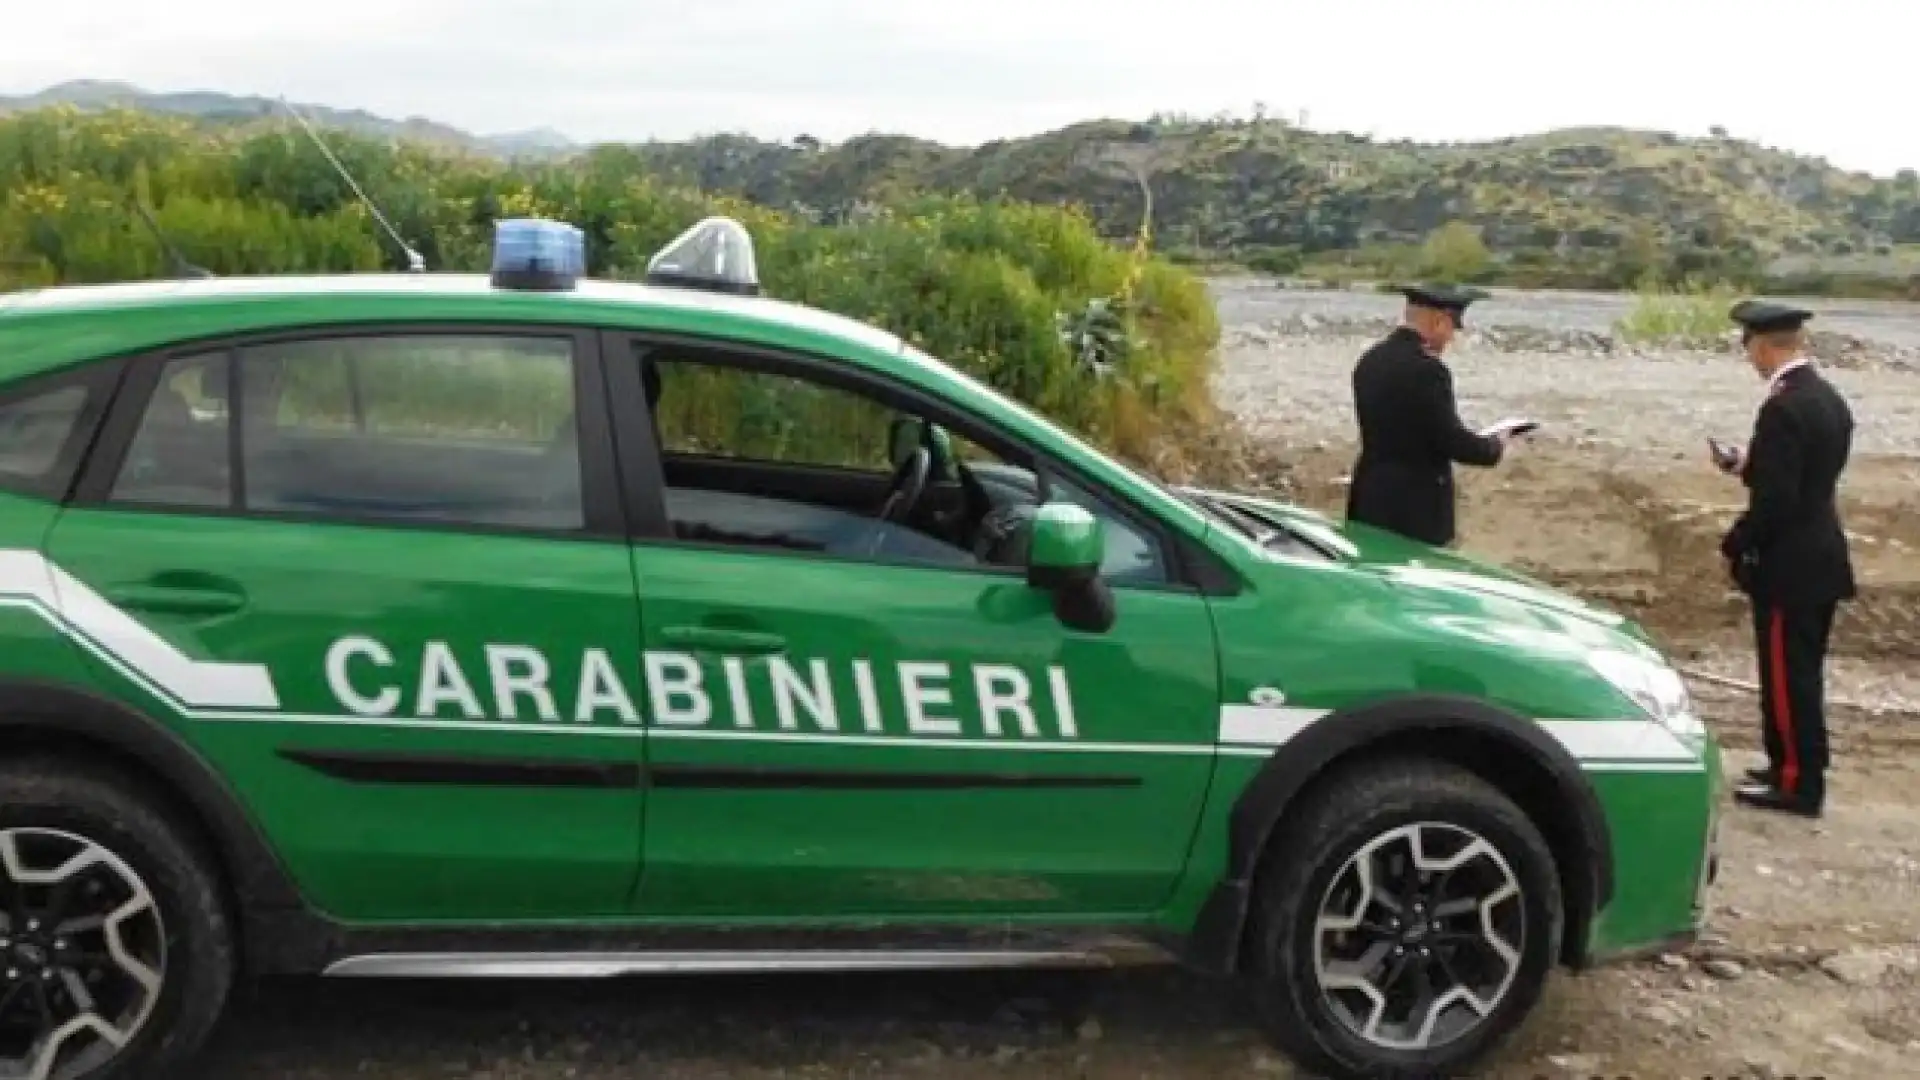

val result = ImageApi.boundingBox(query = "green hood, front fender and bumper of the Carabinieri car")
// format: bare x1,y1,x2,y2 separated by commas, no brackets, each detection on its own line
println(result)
1210,492,1722,955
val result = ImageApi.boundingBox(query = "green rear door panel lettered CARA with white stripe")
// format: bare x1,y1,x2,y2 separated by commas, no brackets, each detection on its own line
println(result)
46,509,643,920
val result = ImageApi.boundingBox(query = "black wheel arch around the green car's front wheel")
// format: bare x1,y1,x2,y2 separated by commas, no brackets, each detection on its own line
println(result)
1187,694,1615,974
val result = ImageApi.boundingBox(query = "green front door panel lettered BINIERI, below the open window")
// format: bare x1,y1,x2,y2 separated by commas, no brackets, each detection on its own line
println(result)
634,544,1219,920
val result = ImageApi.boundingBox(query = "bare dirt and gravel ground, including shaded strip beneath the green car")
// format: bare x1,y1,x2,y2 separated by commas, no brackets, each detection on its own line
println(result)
205,286,1920,1080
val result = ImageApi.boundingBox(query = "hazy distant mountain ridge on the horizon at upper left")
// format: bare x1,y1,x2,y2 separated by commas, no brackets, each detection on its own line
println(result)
0,79,578,158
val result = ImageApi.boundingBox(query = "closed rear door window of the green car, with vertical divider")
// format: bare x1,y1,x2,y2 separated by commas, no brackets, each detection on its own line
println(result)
97,331,588,532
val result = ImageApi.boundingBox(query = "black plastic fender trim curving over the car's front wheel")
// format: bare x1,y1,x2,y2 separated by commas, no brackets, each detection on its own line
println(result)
1183,694,1615,974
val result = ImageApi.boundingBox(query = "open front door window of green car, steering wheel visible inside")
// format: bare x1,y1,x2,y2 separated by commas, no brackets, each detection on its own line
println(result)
637,350,1171,584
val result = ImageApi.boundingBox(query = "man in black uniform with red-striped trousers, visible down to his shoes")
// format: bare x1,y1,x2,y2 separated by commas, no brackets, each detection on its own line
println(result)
1718,300,1855,817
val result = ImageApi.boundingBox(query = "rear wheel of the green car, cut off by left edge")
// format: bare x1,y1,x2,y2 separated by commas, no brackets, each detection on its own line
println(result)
0,759,236,1080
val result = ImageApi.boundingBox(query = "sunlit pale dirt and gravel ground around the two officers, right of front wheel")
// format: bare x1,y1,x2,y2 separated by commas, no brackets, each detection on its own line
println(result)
1217,303,1920,1078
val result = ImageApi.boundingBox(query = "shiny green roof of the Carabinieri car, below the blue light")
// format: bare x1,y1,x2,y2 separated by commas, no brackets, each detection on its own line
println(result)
0,273,924,380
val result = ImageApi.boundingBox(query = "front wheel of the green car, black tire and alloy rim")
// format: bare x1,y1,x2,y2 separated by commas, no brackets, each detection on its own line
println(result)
1248,759,1565,1080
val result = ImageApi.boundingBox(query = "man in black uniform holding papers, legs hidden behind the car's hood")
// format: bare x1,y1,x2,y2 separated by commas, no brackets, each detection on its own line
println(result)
1346,284,1513,546
